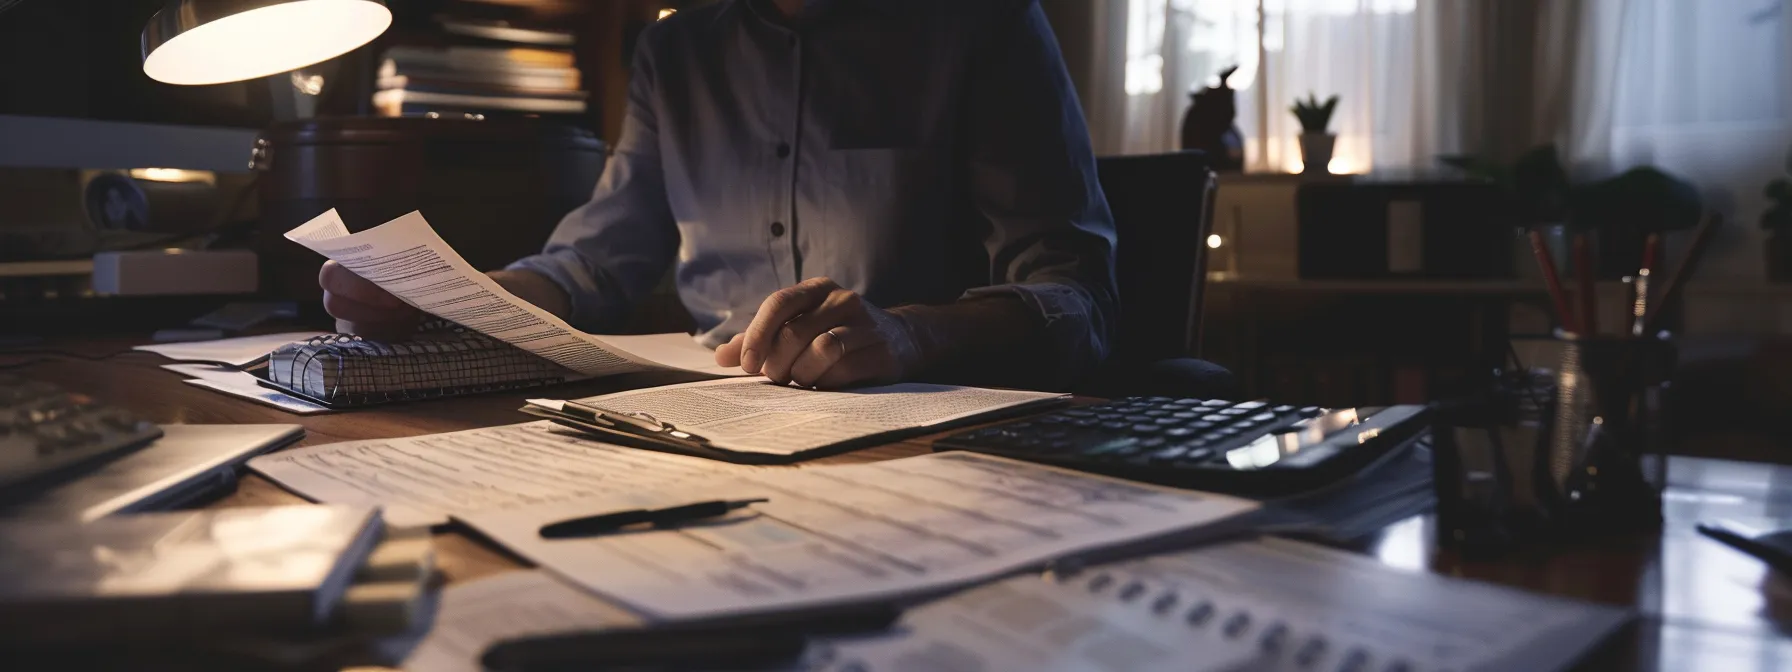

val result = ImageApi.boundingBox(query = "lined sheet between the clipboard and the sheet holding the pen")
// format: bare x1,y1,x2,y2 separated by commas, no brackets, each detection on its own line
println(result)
249,421,754,525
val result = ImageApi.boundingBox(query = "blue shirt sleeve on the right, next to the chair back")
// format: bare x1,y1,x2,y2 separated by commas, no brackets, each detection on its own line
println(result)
966,0,1120,382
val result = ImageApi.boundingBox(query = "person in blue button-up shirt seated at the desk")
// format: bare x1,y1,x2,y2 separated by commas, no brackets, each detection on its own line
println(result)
319,0,1118,389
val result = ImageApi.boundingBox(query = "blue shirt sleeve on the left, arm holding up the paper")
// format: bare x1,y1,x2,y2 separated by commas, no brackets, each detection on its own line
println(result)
509,27,679,332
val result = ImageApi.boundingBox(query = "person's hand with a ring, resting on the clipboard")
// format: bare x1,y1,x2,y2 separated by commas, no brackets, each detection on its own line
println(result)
715,278,921,389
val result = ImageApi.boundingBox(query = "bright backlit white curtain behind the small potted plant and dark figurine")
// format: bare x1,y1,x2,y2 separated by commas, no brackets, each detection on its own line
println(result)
1090,0,1466,172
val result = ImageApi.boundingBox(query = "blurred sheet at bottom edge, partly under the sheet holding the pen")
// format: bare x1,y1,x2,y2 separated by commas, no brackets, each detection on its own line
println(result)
403,570,638,672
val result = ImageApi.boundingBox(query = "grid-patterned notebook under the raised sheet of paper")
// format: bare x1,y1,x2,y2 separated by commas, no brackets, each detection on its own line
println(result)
258,321,582,409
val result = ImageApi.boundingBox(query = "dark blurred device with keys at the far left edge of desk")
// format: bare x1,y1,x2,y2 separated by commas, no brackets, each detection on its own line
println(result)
0,375,161,500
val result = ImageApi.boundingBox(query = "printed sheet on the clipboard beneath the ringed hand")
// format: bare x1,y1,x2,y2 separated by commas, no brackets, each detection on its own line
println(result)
579,378,1066,455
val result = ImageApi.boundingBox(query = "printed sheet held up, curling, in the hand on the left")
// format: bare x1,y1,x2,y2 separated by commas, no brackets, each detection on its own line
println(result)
287,210,656,376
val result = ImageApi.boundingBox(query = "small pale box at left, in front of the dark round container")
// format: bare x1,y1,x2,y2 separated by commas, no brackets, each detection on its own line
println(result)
93,249,260,296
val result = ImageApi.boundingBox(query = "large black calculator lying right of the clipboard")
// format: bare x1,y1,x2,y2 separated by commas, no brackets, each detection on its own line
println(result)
934,396,1425,496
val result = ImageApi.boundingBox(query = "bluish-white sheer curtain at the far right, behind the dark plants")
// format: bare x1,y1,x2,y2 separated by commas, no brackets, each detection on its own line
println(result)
1538,0,1792,280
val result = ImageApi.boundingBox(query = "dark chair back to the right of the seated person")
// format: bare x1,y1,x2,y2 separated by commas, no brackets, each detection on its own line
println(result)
1095,152,1217,362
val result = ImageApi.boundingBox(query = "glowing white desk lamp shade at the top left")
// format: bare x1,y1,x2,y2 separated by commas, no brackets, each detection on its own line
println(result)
143,0,392,84
